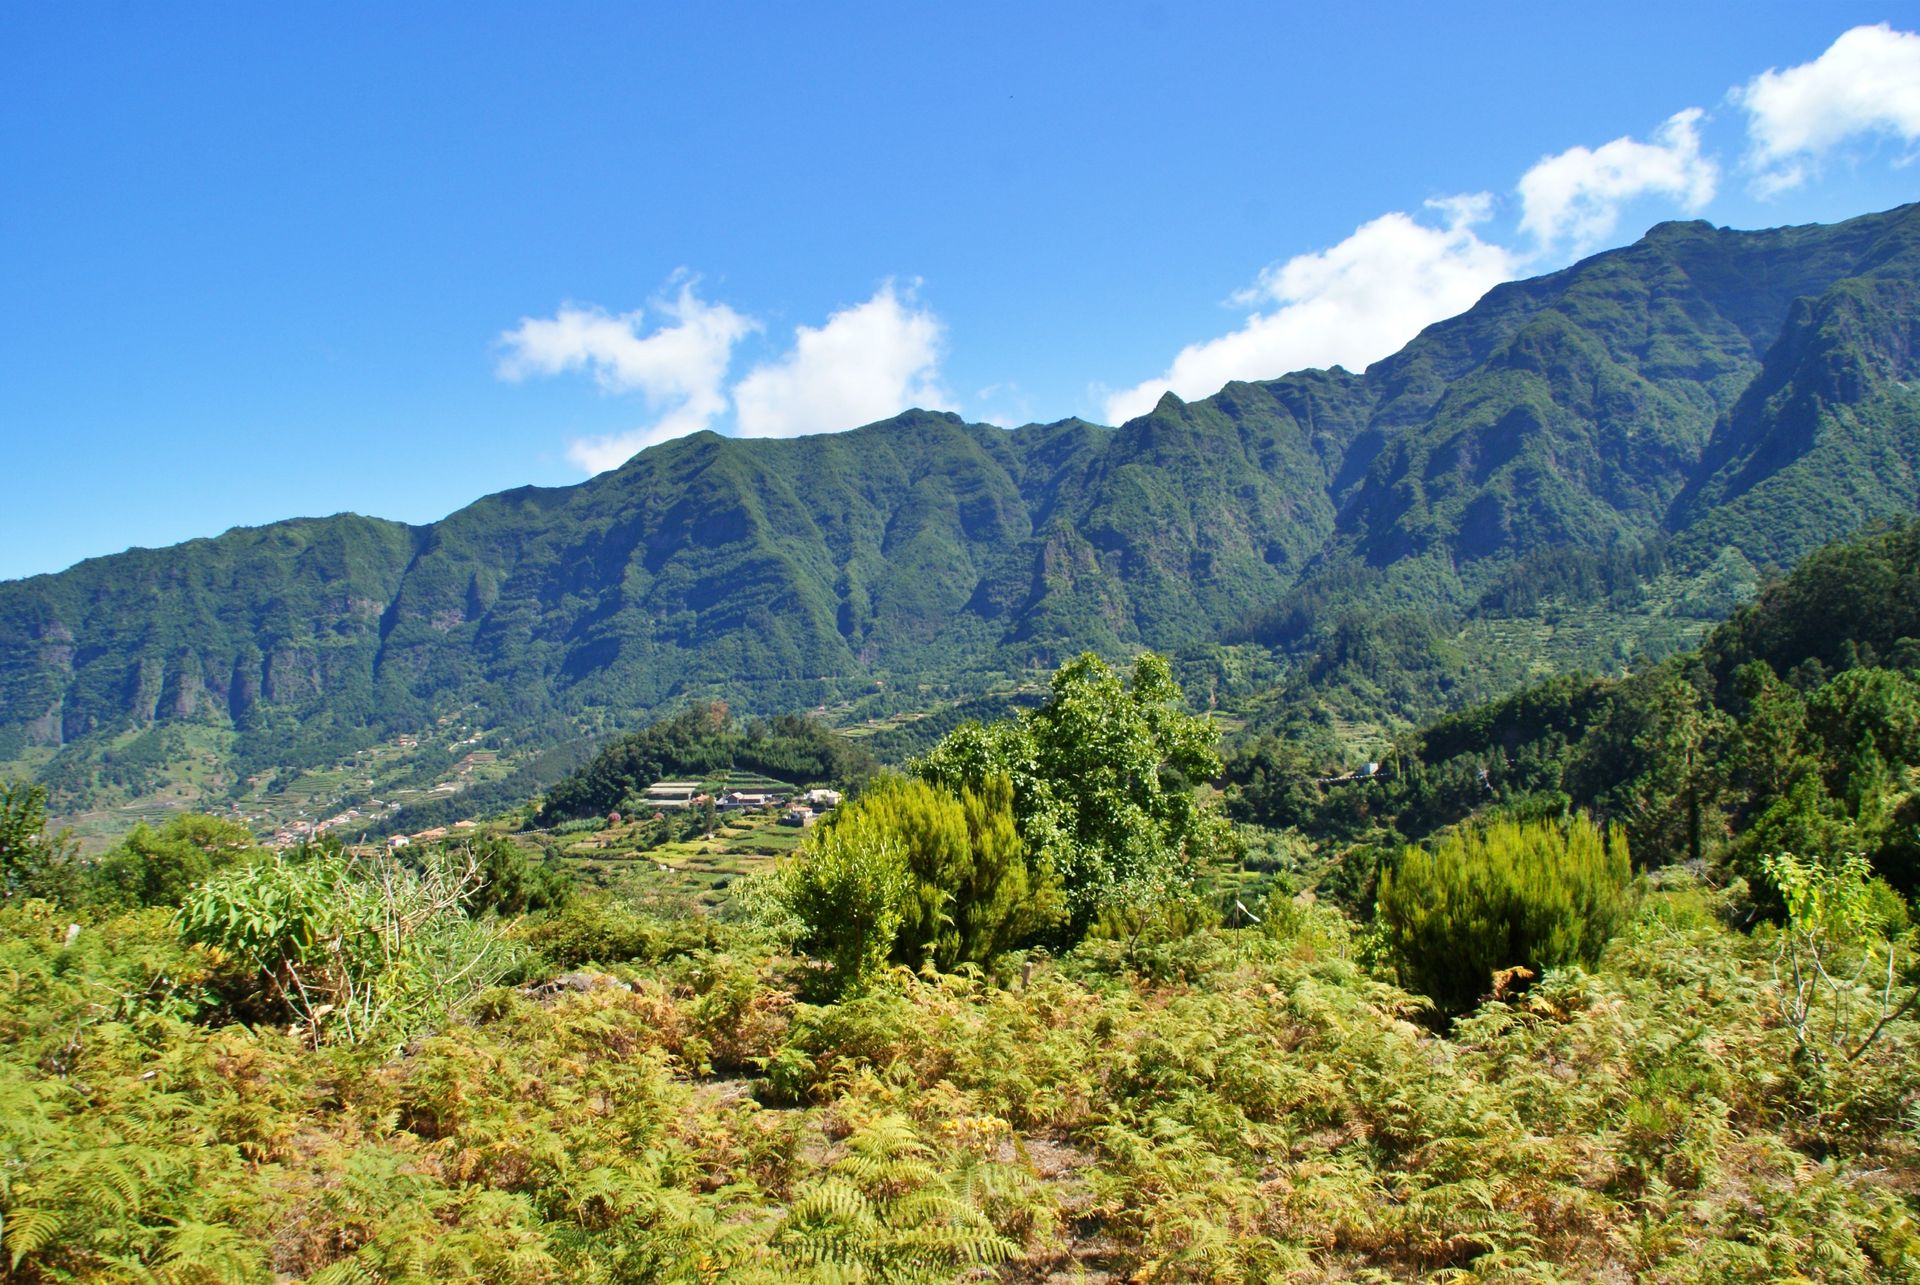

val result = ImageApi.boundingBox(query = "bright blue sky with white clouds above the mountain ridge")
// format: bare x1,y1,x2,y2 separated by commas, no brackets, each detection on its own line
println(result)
0,0,1920,578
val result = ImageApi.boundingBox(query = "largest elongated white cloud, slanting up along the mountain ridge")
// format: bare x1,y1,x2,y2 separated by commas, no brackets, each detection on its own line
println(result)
1106,192,1517,424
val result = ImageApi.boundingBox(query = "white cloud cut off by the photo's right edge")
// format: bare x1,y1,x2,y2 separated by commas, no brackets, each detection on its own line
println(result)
1732,23,1920,196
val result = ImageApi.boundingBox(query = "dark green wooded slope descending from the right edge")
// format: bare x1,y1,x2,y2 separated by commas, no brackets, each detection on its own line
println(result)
1225,524,1920,897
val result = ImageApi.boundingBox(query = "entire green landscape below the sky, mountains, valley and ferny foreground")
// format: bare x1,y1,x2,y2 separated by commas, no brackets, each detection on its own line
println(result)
11,206,1920,1285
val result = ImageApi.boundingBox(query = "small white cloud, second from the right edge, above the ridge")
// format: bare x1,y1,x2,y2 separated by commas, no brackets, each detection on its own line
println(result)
1519,108,1720,254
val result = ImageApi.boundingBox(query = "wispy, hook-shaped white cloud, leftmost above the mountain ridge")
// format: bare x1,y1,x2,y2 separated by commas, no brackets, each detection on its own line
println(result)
495,280,760,473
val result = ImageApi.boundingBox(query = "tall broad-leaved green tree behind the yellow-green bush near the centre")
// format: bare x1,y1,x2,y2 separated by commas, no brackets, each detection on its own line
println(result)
914,653,1229,937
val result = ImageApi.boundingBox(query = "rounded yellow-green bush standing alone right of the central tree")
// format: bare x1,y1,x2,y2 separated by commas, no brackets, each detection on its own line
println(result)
1380,816,1630,1014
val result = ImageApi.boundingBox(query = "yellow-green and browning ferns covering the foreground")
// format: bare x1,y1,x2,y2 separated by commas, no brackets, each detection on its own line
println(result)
0,880,1920,1285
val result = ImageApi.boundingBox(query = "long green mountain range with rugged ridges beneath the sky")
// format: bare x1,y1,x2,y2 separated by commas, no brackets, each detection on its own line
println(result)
0,206,1920,818
